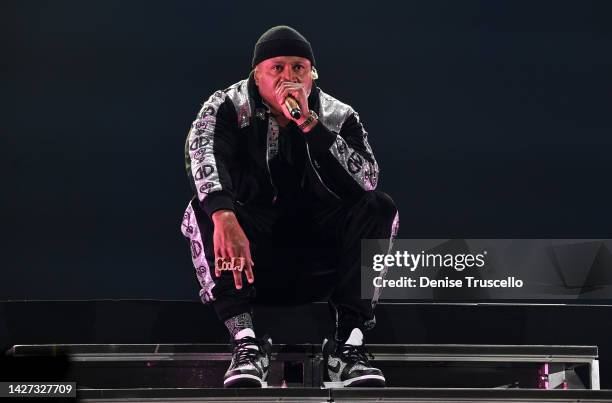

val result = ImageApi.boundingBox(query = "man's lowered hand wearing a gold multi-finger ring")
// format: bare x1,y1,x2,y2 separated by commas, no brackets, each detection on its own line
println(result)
212,210,255,290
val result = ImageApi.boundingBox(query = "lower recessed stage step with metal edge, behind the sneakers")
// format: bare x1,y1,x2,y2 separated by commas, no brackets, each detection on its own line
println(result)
7,344,600,390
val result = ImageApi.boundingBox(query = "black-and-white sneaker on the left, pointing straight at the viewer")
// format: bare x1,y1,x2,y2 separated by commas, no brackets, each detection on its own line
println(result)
223,334,272,388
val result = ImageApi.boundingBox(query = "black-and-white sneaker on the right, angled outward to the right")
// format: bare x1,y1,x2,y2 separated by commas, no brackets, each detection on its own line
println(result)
322,328,385,387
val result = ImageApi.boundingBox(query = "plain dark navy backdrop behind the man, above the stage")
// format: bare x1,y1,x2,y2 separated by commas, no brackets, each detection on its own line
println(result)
0,0,612,300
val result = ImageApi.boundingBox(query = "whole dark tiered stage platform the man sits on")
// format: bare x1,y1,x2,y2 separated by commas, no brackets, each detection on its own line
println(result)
0,301,612,402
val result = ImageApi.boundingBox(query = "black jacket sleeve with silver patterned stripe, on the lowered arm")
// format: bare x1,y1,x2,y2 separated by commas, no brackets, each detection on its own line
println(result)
185,91,238,217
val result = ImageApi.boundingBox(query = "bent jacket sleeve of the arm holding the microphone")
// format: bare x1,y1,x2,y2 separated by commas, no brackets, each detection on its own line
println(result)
305,108,379,197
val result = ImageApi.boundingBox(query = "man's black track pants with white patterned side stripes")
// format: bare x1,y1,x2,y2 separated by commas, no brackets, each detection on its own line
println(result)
183,191,398,336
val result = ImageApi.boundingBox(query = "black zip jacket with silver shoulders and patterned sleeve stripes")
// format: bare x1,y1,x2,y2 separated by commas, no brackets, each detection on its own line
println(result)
185,73,379,216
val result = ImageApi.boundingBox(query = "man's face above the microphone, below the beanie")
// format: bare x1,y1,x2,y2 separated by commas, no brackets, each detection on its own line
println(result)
255,56,312,113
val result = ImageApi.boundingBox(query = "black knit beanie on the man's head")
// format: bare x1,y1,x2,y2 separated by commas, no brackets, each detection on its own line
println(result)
252,25,315,67
